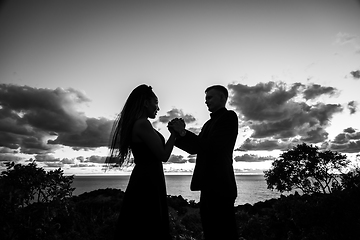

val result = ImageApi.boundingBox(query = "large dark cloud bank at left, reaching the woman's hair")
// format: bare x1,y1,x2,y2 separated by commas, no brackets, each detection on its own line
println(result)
0,84,113,154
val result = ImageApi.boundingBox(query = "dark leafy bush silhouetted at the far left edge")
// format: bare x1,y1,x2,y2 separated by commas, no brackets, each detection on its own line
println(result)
0,161,74,239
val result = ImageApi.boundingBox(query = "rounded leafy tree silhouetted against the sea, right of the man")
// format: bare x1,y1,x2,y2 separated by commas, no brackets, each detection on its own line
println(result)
264,143,350,193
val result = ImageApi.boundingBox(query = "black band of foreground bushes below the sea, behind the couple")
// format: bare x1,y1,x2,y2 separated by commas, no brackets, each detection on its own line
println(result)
0,161,360,240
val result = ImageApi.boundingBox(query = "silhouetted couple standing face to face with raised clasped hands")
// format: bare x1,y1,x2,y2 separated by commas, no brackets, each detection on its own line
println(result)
107,85,238,240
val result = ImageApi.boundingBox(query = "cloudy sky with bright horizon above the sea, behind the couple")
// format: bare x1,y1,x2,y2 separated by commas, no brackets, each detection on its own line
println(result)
0,0,360,174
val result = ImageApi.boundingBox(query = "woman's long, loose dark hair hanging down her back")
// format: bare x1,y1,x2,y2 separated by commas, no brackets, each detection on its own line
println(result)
106,84,156,167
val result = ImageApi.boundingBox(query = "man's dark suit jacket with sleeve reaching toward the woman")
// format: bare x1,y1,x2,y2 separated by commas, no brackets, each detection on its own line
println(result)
175,108,238,199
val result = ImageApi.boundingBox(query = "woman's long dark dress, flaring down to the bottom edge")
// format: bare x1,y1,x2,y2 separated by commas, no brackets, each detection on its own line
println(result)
115,132,171,240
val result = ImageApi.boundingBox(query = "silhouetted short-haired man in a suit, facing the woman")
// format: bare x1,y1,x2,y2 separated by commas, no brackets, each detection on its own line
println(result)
169,85,238,240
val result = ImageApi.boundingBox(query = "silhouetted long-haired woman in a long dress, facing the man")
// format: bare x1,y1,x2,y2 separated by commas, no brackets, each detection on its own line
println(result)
107,85,175,240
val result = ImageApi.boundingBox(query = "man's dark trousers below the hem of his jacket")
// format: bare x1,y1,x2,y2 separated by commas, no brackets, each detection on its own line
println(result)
200,191,239,240
